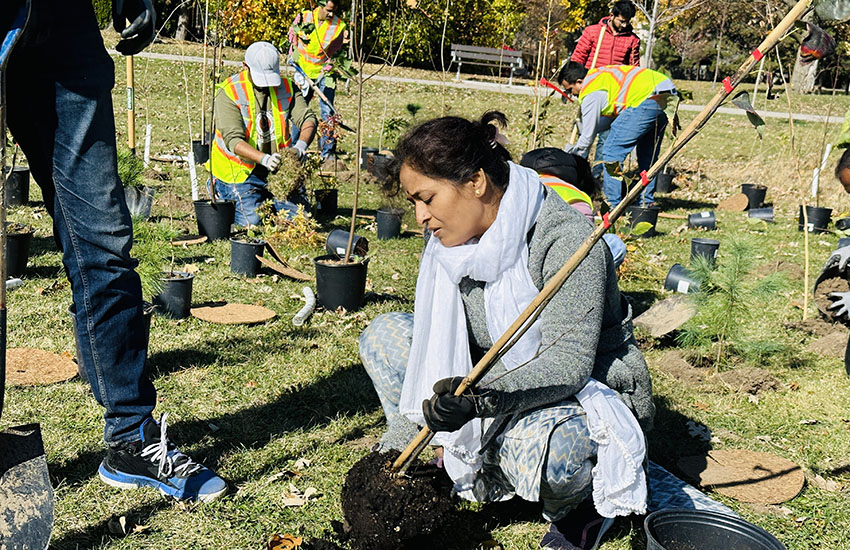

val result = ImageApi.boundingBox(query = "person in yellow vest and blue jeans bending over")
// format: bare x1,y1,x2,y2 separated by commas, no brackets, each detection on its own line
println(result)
558,61,678,208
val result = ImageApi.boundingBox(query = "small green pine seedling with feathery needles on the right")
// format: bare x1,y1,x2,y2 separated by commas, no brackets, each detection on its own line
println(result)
677,236,787,368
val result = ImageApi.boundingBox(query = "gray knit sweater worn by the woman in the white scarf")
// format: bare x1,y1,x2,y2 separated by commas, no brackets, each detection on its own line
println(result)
460,192,655,445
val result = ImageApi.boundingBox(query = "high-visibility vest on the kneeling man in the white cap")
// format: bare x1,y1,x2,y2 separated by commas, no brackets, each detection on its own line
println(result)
207,69,293,183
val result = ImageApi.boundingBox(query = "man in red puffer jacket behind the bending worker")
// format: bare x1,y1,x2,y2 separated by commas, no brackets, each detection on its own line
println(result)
570,0,640,179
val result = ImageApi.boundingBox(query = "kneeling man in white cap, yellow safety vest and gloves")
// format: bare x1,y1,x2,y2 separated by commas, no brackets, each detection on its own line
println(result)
207,42,318,227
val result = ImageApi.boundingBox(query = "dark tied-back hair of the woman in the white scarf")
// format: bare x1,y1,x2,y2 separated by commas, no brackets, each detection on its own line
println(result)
384,111,511,193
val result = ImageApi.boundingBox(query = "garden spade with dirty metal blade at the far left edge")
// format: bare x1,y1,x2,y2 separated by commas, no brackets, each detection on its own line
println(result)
0,0,53,550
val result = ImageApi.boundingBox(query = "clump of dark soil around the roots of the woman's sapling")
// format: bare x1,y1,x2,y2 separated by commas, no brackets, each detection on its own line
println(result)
341,451,455,550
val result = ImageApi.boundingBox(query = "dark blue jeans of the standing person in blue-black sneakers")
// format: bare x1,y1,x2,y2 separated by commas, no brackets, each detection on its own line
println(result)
6,24,156,445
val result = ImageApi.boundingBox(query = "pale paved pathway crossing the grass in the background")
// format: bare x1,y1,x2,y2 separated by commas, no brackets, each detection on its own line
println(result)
117,50,844,124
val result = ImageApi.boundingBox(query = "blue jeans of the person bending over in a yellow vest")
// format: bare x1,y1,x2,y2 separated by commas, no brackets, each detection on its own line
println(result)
602,99,667,208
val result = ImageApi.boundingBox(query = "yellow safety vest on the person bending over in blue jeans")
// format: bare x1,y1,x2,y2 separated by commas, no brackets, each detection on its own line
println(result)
578,65,669,116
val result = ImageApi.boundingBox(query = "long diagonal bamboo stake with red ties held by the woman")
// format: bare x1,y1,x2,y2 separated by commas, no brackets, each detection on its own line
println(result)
392,0,812,474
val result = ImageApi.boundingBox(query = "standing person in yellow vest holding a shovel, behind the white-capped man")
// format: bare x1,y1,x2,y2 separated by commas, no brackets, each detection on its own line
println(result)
289,0,348,164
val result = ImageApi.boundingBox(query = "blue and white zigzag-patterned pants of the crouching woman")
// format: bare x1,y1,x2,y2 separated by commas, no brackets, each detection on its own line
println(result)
360,313,596,521
